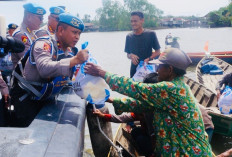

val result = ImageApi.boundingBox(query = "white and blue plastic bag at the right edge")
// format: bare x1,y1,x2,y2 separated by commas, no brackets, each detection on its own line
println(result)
218,86,232,114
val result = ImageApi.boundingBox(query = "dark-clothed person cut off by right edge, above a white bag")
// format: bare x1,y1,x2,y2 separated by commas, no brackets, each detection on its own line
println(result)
216,73,232,99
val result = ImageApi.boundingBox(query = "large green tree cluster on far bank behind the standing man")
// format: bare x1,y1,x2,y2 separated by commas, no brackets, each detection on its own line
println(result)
77,0,163,31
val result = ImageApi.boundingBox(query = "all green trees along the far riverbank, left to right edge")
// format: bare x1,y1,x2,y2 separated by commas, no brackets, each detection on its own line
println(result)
77,0,232,31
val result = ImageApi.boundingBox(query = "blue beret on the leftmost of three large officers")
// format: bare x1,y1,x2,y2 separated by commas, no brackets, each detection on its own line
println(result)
23,3,46,15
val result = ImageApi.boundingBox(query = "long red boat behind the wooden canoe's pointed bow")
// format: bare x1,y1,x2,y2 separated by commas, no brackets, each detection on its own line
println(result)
186,51,232,64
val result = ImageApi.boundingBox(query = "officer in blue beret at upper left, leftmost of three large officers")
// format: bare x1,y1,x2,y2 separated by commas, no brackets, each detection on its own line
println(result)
12,3,46,67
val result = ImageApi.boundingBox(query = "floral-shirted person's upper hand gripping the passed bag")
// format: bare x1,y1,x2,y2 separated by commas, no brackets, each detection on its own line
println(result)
84,63,106,77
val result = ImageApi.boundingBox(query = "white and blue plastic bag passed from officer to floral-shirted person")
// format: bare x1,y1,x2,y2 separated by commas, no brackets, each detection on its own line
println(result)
72,43,110,104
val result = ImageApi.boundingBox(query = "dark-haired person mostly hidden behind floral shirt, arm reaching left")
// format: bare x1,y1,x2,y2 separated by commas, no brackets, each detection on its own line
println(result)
93,73,158,157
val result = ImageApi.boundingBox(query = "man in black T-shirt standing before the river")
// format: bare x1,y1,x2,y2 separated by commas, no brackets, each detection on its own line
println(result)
125,11,160,77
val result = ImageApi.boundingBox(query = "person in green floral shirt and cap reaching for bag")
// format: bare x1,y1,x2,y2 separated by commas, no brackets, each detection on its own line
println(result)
85,48,212,157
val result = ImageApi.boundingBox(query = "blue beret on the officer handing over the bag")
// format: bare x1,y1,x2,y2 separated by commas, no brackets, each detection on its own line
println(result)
59,13,85,32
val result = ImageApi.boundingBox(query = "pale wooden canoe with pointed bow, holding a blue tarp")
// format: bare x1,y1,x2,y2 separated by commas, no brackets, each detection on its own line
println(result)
196,56,232,93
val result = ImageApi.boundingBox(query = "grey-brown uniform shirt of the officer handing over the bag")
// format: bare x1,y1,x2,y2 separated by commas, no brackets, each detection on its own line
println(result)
24,35,72,82
